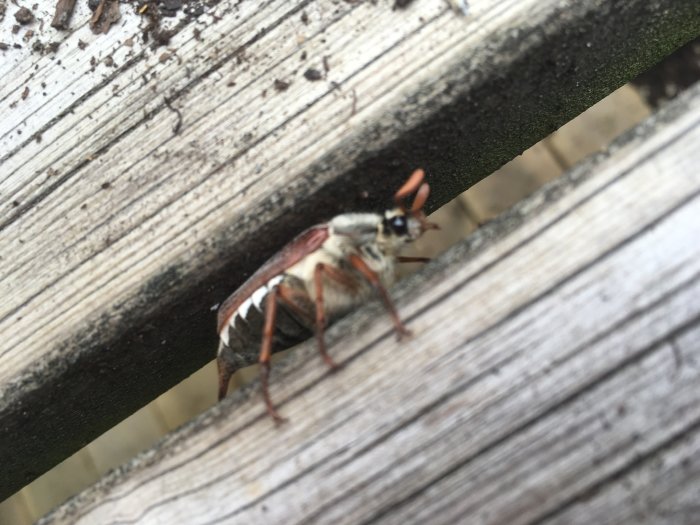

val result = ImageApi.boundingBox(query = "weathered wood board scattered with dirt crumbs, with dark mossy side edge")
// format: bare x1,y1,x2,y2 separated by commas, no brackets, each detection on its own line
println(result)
0,0,700,498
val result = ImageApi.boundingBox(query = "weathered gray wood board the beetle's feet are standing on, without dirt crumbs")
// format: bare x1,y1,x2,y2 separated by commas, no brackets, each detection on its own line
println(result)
43,82,700,524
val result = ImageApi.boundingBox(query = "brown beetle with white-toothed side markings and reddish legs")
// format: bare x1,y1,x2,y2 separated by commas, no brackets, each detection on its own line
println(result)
217,169,438,422
